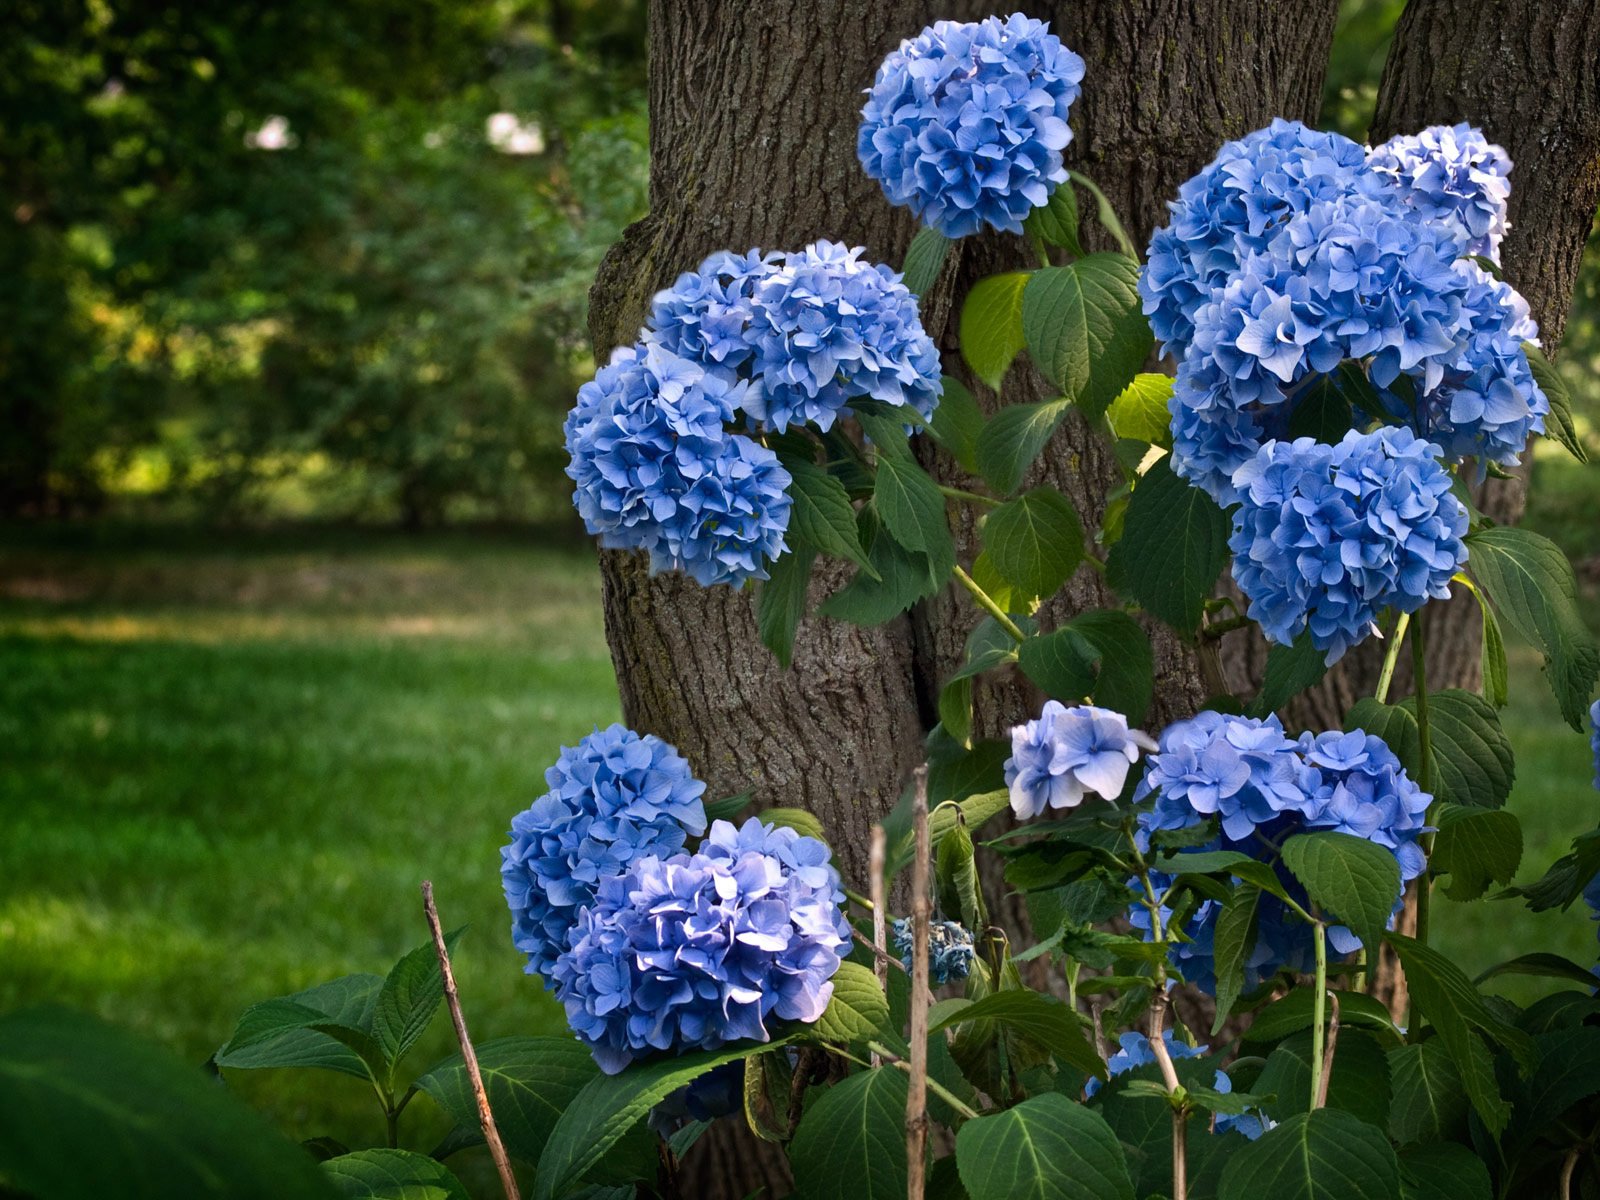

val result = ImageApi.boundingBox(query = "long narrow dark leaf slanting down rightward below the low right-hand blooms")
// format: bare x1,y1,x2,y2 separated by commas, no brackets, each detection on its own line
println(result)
1387,933,1533,1134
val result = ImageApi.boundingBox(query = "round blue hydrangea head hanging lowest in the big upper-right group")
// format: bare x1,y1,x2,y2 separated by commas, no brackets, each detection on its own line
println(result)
1229,427,1467,664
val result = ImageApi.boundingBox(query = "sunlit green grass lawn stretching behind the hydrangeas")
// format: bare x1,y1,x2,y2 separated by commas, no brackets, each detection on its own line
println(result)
0,518,1600,1149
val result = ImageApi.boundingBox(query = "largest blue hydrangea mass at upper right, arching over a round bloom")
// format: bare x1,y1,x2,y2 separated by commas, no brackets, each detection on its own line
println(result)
1141,122,1549,504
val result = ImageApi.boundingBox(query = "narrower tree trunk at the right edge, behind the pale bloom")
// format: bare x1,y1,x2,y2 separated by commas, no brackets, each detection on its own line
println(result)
1324,0,1600,1016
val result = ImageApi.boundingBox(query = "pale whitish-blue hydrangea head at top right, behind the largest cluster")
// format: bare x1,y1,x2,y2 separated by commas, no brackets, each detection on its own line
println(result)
1366,122,1510,262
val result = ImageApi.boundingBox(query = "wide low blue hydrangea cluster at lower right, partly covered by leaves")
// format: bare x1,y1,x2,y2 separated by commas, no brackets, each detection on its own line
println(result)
1128,712,1432,992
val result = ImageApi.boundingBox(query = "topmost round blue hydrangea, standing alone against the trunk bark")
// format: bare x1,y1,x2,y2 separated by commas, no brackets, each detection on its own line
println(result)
856,13,1083,237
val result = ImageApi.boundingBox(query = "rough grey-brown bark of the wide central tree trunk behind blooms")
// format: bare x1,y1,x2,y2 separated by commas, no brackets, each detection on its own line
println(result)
590,0,1338,1197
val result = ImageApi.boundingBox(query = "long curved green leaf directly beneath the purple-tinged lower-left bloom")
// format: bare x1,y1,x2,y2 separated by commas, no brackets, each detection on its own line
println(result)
533,1038,789,1200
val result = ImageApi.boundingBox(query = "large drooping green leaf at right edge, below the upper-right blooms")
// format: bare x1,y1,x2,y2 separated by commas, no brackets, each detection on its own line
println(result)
1467,525,1600,730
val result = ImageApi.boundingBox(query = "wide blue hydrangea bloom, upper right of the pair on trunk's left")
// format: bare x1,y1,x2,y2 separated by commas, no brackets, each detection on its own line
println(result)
650,242,942,432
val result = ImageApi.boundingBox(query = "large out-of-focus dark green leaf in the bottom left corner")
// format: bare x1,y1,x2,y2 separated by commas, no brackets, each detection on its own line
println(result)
0,1008,336,1200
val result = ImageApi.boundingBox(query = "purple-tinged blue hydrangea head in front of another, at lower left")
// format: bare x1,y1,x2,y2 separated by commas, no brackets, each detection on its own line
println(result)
552,818,850,1074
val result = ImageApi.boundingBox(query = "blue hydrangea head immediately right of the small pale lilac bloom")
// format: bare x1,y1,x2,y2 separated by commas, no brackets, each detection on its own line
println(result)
1133,710,1317,842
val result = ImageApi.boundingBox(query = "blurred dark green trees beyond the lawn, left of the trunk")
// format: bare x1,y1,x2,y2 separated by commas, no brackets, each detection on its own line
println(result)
0,0,646,526
